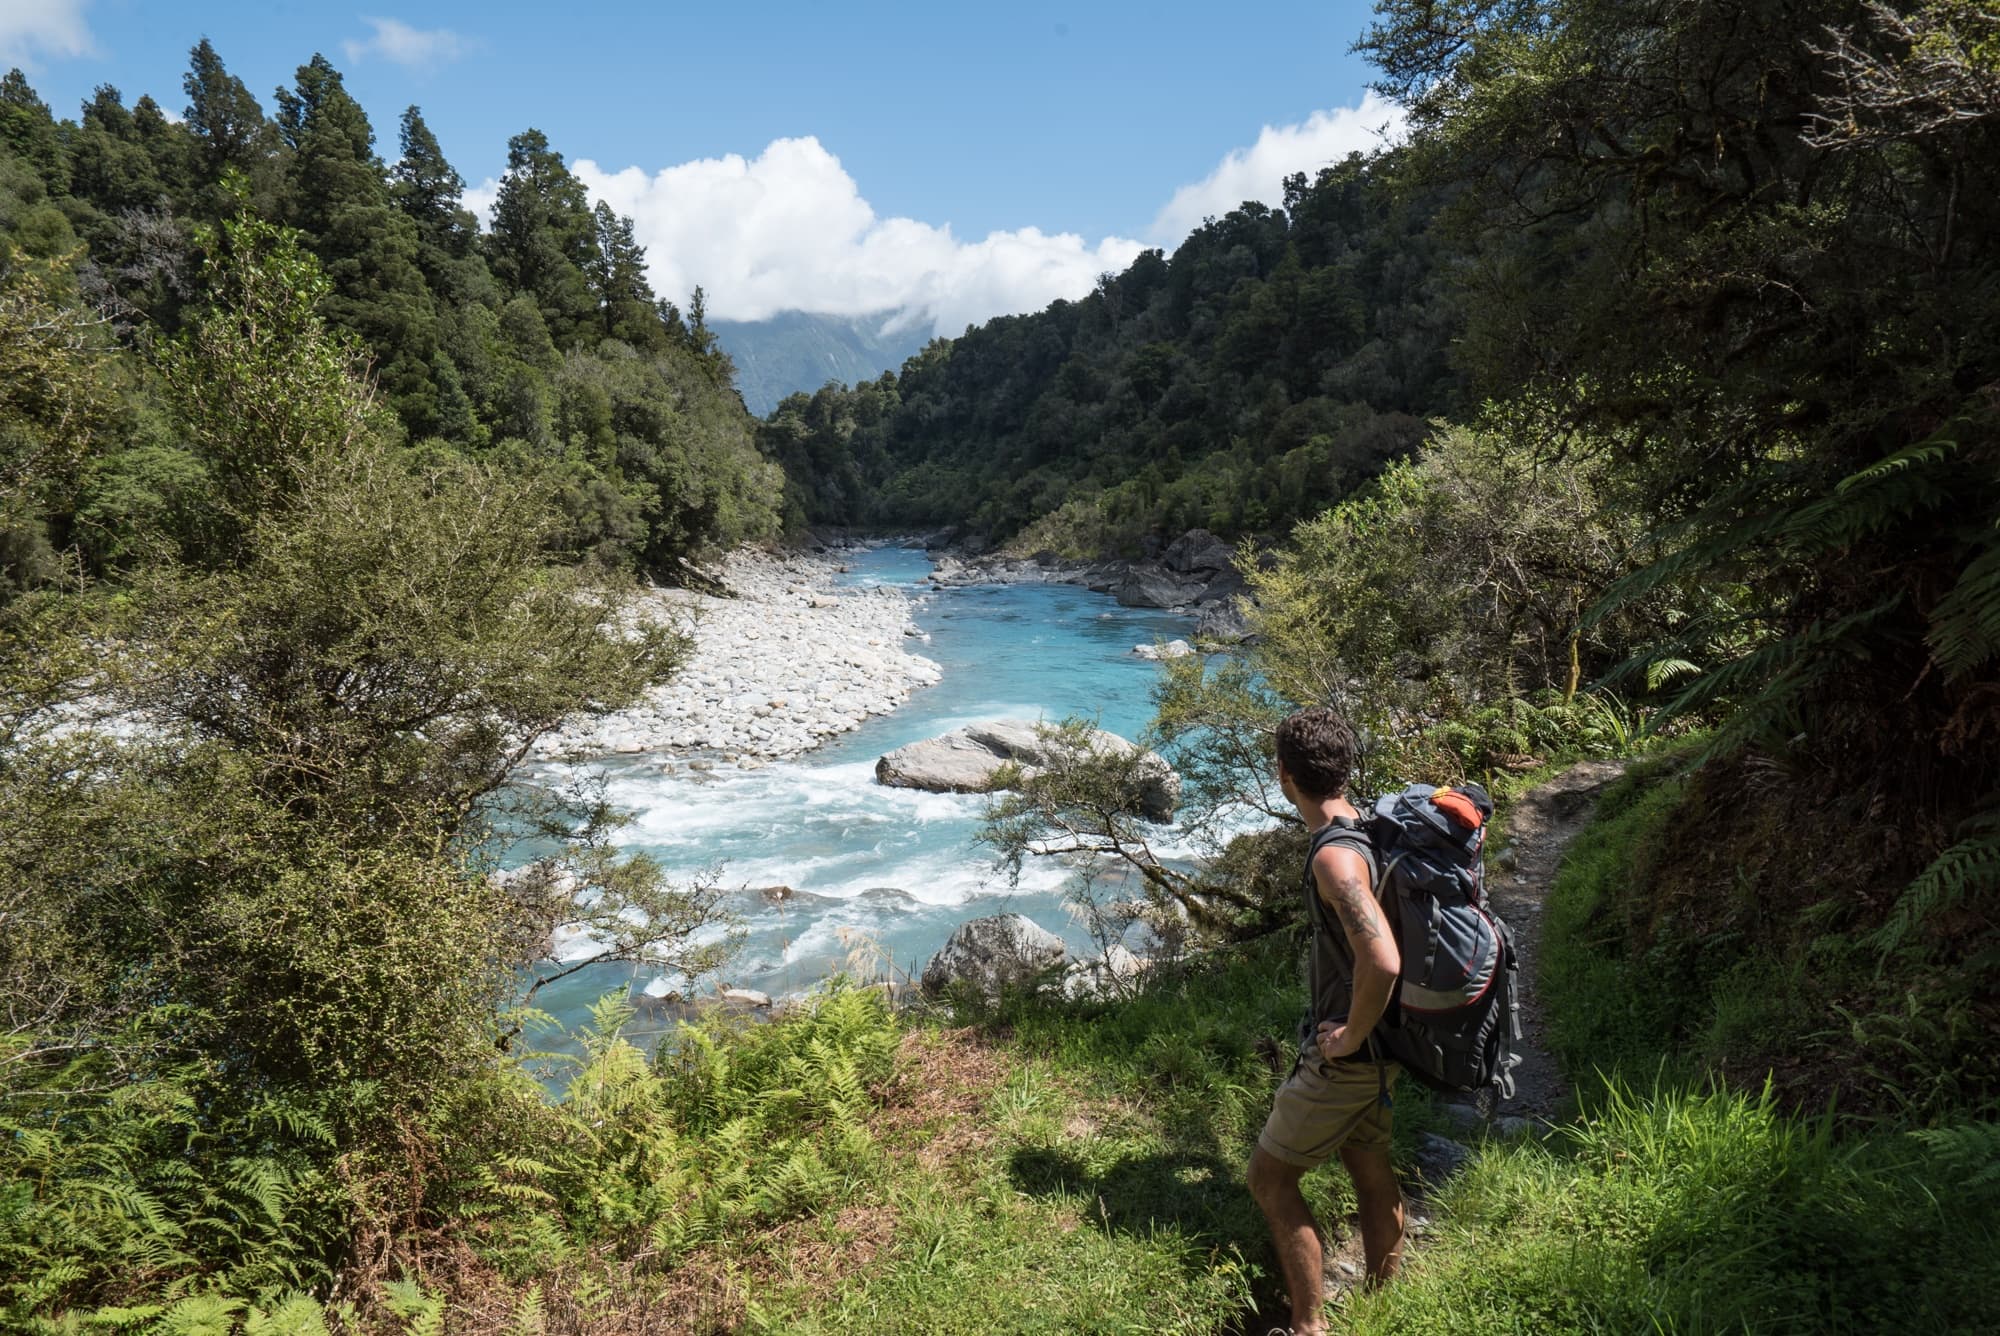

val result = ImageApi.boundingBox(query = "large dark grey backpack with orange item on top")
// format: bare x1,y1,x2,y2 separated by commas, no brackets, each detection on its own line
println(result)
1340,784,1520,1104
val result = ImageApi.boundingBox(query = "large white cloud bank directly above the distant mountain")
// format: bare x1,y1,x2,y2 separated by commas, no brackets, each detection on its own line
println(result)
572,136,1144,334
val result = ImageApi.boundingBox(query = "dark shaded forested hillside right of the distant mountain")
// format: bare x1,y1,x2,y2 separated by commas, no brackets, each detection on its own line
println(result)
758,158,1460,556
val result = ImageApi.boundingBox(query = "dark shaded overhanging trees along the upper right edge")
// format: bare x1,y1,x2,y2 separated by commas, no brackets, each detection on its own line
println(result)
1364,0,2000,1012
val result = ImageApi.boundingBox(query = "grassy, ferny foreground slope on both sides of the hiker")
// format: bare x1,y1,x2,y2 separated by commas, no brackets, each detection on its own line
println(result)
352,756,2000,1334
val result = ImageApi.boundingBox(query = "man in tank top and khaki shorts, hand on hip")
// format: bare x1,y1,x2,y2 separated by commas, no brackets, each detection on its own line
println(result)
1250,708,1402,1336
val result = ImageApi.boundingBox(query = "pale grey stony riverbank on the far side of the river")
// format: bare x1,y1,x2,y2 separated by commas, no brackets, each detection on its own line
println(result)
536,548,942,768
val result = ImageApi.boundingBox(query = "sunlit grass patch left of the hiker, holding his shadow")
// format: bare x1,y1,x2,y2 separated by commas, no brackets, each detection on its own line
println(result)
762,936,1424,1332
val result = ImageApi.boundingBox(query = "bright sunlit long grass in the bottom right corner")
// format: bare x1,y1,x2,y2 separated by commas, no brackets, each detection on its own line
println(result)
1344,1082,2000,1336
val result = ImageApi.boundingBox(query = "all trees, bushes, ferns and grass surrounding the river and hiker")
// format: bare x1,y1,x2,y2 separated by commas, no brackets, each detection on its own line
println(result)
0,0,2000,1334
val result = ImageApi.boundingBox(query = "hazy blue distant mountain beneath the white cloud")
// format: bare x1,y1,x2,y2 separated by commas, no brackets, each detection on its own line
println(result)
708,310,930,418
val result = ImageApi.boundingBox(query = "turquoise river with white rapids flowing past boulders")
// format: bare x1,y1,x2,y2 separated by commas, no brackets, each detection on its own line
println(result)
520,548,1232,1026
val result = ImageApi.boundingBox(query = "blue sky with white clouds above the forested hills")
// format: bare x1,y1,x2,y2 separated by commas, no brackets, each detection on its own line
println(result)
0,0,1392,324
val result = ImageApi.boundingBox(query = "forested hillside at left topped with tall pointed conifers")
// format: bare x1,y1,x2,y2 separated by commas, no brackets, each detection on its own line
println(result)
0,40,778,584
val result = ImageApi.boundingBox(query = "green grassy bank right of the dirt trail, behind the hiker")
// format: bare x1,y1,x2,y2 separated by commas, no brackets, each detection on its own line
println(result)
1342,756,2000,1334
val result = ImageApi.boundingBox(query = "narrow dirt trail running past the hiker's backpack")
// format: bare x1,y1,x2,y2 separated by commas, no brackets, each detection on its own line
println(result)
1486,760,1626,1118
